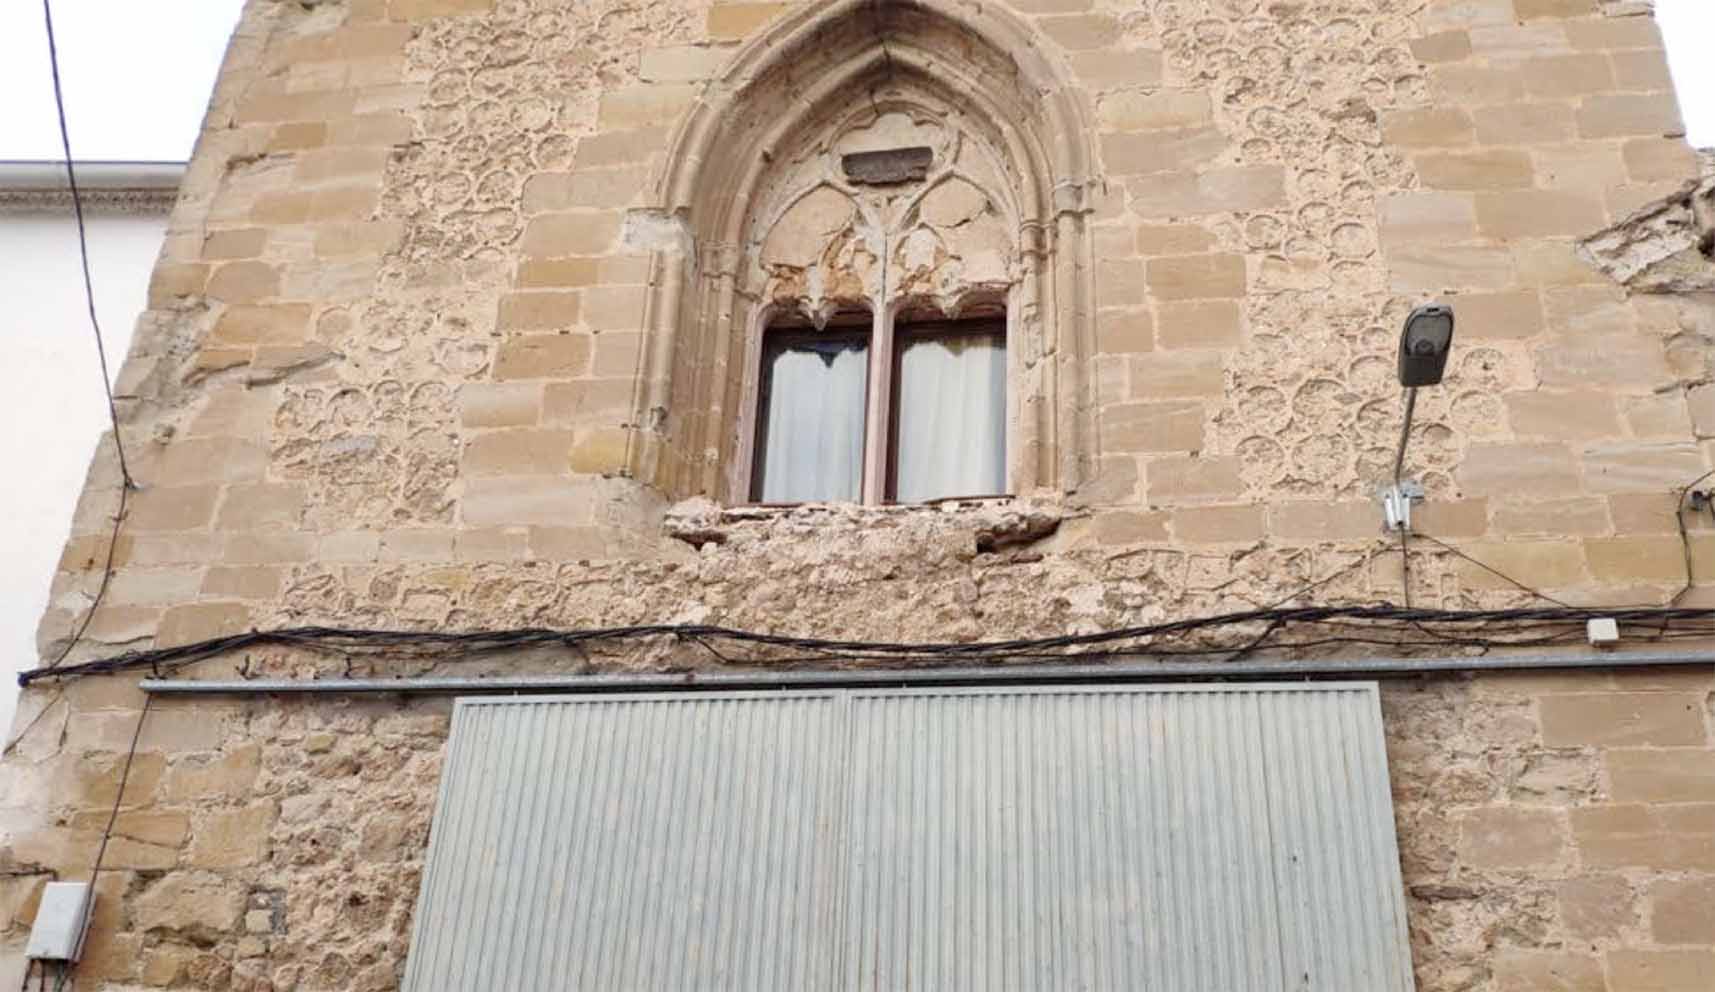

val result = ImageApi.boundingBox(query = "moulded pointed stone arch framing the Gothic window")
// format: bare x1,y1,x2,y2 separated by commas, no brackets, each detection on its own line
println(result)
629,0,1098,501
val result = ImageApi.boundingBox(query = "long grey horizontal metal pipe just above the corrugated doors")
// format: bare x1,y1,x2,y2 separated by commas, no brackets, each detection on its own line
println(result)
142,652,1715,695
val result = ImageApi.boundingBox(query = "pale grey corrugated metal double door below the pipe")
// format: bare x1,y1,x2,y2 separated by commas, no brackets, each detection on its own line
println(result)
405,683,1413,992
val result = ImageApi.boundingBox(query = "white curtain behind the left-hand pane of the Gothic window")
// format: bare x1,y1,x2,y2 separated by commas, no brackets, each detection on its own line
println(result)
760,342,870,503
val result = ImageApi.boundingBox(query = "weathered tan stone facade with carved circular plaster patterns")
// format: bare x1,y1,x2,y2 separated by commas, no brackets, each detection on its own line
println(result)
0,0,1715,992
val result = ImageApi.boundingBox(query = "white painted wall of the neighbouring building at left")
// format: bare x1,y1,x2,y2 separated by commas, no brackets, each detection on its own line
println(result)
0,211,166,740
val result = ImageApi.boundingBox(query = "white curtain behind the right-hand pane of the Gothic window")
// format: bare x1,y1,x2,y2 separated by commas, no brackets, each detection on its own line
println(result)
895,335,1007,503
